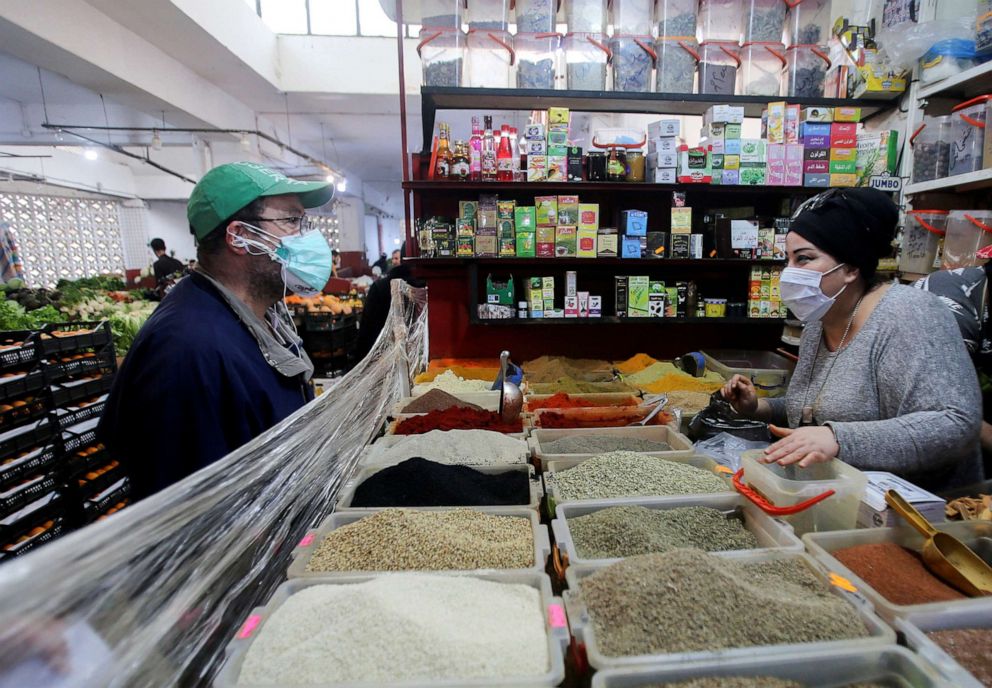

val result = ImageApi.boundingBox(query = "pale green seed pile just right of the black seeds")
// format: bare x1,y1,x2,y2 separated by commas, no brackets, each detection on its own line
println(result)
545,452,730,501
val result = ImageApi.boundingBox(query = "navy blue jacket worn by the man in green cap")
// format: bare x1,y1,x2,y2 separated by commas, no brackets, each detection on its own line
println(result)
100,273,310,499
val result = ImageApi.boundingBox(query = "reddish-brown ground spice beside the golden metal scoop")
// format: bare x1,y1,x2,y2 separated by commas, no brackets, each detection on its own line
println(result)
832,542,964,605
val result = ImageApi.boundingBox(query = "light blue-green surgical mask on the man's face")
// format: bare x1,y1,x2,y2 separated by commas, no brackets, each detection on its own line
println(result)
228,222,333,296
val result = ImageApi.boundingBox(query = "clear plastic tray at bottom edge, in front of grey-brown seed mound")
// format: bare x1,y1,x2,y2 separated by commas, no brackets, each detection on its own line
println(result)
592,645,950,688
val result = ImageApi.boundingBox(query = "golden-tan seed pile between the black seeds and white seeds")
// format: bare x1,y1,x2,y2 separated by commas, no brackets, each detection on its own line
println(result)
307,509,534,572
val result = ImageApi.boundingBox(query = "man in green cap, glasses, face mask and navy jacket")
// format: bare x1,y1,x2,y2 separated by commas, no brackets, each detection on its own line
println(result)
99,162,333,499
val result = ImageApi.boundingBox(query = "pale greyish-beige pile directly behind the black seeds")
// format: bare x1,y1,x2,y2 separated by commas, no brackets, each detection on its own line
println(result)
367,430,527,466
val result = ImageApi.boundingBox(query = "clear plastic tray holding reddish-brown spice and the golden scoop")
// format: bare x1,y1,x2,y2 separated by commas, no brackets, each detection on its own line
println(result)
802,521,992,621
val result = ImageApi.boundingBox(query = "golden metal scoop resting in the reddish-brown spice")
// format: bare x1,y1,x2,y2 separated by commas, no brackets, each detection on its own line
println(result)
885,490,992,597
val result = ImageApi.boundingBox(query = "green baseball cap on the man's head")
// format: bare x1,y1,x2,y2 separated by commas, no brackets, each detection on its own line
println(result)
186,162,334,240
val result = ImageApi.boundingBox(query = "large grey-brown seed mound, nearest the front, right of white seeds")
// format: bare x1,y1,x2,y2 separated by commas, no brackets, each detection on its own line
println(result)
579,549,867,656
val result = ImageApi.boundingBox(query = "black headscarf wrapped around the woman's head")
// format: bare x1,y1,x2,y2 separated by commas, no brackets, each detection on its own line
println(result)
789,188,899,282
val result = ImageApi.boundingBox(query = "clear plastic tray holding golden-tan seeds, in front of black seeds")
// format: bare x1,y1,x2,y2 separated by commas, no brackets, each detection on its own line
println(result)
286,506,551,580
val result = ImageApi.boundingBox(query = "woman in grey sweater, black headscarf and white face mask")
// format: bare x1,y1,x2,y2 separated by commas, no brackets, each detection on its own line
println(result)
723,188,982,491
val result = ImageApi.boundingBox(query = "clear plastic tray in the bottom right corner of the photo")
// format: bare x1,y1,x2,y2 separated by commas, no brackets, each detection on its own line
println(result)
893,605,992,688
